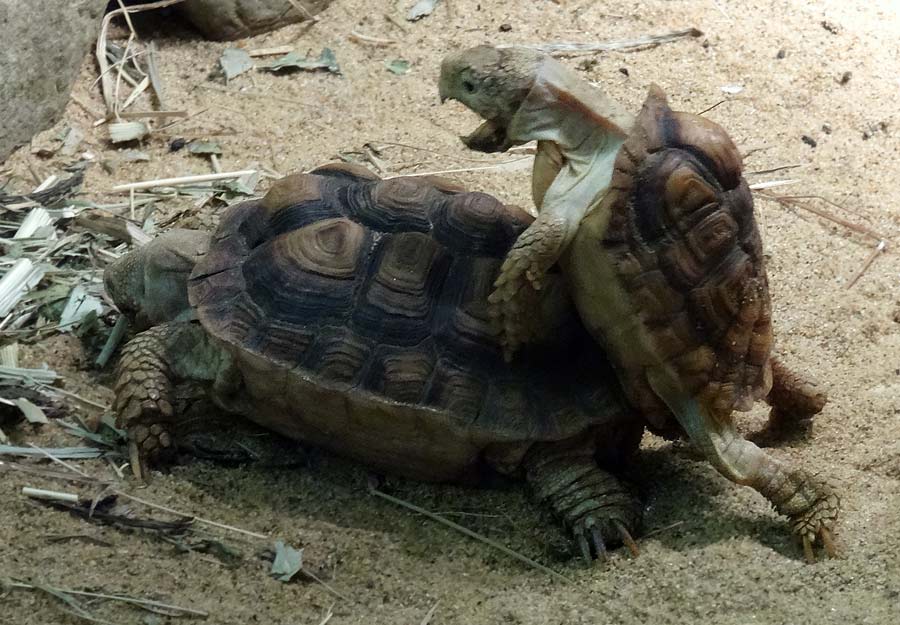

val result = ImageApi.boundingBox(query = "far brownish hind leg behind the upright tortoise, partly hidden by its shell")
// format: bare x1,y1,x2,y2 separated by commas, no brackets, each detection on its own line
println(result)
752,357,828,445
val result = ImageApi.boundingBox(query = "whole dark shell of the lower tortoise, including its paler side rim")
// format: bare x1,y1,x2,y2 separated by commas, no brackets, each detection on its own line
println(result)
189,166,641,479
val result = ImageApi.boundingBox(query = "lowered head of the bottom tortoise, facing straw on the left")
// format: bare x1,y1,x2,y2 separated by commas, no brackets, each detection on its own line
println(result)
103,229,210,330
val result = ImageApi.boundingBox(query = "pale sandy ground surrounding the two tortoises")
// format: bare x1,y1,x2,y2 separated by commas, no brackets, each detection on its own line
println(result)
0,0,900,625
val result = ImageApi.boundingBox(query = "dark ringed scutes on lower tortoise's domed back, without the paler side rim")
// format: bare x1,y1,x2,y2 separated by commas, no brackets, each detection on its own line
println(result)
190,168,632,439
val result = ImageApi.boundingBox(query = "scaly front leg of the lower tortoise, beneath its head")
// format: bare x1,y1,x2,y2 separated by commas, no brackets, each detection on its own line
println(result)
114,322,208,480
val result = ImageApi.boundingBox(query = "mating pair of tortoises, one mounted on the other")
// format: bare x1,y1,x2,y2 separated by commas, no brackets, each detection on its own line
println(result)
106,47,838,558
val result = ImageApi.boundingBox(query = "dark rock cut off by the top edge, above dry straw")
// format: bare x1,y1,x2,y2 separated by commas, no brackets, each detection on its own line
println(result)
180,0,331,40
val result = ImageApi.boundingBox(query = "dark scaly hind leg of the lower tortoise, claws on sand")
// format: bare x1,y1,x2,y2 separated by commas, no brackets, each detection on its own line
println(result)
525,443,642,562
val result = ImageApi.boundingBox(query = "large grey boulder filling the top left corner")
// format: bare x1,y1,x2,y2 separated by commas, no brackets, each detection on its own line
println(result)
0,0,107,163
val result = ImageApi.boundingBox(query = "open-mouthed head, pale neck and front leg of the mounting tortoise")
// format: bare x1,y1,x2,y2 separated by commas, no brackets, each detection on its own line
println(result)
439,46,632,360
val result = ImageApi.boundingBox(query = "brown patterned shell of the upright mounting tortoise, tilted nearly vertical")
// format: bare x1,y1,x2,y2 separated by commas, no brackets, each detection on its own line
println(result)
604,88,772,428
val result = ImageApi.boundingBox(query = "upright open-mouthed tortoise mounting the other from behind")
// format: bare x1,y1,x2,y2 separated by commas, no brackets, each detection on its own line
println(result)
439,46,839,559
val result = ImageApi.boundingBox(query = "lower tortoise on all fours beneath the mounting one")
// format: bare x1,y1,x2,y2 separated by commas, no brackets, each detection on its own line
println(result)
104,164,645,559
